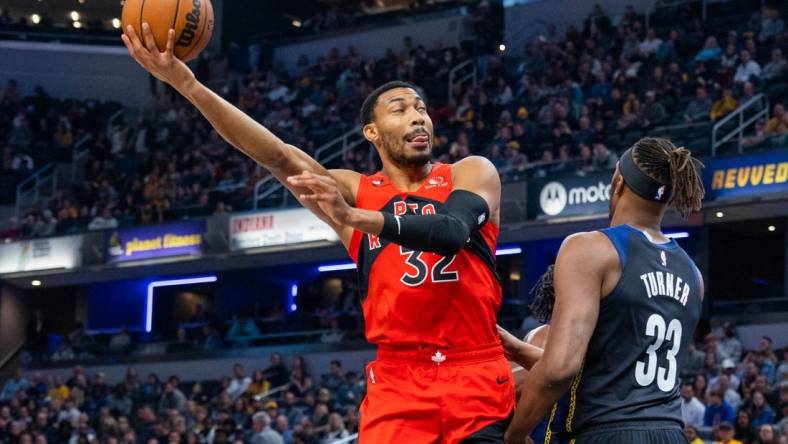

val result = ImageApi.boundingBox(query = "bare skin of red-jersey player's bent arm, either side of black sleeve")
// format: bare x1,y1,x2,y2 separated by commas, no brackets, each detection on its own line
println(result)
287,156,501,235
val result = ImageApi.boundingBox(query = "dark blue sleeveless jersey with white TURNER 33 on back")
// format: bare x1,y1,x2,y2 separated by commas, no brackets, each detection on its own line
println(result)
566,225,702,434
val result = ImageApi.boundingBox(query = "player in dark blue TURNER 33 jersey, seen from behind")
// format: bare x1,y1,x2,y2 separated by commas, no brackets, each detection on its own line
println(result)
505,138,704,444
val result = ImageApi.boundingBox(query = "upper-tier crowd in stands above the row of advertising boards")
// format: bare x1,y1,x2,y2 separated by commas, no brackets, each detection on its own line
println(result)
0,2,788,243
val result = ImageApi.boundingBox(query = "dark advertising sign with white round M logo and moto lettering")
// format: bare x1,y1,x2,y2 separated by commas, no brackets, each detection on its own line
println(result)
528,172,613,219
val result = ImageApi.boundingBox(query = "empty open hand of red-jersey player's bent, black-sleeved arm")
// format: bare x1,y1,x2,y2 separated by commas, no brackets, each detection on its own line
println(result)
287,171,353,225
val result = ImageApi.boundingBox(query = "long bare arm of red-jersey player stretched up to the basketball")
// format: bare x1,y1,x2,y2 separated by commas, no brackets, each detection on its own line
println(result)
121,23,358,240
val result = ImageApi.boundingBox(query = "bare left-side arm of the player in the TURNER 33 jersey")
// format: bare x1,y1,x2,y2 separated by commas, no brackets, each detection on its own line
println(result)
505,232,618,444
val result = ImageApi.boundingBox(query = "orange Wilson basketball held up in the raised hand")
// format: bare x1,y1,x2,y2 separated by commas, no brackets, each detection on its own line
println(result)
121,0,213,62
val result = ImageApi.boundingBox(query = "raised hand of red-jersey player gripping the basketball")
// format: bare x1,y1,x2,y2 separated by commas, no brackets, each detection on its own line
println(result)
120,22,199,93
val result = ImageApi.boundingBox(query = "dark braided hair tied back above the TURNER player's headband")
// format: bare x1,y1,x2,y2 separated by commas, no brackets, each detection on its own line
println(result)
632,137,706,219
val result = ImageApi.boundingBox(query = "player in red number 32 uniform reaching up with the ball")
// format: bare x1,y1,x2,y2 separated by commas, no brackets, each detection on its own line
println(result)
122,24,541,444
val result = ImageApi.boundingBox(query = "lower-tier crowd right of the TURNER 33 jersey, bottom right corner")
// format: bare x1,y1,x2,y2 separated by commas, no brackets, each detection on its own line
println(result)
681,324,788,444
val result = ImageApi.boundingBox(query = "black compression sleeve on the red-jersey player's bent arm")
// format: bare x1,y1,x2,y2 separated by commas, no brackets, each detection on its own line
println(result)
380,190,490,256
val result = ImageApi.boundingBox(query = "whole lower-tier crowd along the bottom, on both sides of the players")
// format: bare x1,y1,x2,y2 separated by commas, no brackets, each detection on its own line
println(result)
0,318,788,444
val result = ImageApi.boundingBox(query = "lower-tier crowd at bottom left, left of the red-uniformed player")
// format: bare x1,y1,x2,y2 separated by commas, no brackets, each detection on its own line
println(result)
0,353,366,444
